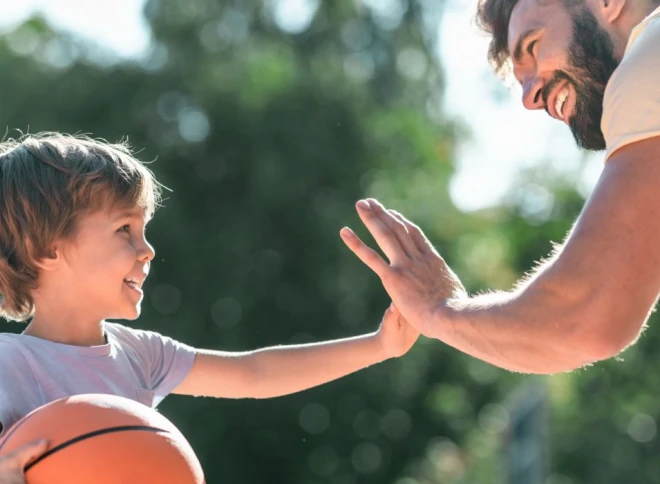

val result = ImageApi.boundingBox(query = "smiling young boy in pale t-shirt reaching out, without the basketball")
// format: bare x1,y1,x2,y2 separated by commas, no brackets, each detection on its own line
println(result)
0,133,419,446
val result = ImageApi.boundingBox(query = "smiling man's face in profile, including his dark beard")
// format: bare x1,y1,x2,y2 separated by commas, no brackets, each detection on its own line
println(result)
509,0,619,150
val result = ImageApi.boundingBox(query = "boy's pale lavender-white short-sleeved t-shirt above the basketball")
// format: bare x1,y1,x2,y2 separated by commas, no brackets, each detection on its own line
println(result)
0,322,195,435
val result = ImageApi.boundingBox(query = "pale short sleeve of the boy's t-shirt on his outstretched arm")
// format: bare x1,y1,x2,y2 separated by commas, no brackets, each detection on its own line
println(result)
122,329,195,401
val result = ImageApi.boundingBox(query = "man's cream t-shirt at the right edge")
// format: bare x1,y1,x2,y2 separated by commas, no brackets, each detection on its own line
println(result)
601,8,660,160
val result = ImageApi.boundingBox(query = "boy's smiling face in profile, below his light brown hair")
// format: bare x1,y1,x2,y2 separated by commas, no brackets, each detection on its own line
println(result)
56,204,155,319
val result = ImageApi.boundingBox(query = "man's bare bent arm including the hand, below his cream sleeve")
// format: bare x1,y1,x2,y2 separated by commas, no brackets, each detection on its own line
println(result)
341,137,660,373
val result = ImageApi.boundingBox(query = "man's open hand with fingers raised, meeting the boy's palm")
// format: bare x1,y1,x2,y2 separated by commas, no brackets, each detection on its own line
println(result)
341,199,467,336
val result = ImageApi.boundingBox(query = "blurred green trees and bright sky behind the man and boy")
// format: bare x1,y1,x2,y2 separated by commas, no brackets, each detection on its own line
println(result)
0,0,660,484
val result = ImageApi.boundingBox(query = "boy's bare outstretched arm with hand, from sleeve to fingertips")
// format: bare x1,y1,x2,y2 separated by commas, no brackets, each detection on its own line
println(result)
173,305,419,398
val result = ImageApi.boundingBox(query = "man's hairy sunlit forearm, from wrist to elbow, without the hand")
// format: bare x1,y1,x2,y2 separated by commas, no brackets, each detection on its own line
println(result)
423,274,601,373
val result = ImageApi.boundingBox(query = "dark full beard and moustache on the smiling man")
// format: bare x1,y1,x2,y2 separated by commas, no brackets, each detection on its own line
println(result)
543,8,619,151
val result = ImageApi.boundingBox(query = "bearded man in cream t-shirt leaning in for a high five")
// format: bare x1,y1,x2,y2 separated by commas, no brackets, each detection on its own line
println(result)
341,0,660,373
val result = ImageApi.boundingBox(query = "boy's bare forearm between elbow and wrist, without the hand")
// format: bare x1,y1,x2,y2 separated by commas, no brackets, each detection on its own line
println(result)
244,333,386,398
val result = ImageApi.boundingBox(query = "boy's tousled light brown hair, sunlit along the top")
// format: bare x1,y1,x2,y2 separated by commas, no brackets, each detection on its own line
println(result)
0,133,161,321
